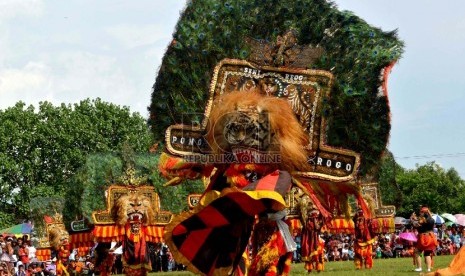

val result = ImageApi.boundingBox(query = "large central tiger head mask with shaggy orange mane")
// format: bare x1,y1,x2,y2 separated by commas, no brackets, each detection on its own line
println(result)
206,88,308,171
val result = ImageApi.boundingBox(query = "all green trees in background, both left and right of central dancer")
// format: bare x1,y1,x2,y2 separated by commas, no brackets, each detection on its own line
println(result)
0,99,465,229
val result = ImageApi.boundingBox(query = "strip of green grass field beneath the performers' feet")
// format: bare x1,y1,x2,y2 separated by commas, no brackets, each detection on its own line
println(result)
150,256,454,276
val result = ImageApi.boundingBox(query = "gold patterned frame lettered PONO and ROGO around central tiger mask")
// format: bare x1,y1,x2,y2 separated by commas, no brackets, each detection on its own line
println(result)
165,59,360,182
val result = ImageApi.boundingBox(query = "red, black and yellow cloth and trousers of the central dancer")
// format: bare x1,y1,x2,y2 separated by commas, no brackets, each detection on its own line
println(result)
165,167,292,275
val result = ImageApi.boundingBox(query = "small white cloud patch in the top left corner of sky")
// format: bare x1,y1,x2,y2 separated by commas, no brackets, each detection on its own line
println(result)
0,0,44,22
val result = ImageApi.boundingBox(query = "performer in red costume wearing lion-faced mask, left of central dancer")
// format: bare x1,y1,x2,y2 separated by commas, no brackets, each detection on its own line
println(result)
92,185,161,276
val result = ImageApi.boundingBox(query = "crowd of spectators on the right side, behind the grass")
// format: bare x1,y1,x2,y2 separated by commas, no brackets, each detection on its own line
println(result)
293,224,465,262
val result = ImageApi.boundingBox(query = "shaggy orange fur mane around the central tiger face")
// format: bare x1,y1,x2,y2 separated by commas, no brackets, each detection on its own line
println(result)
206,89,308,172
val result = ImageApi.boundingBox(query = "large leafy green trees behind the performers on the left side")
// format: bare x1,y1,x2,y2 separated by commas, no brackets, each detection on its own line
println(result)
0,98,200,229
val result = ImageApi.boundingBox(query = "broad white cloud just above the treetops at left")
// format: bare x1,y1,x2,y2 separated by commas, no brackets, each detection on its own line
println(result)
0,51,141,109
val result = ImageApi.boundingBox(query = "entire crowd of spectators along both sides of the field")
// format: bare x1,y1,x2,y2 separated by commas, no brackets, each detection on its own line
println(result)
0,224,465,276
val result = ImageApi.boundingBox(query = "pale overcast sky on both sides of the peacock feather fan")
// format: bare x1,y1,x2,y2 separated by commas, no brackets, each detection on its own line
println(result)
0,0,465,178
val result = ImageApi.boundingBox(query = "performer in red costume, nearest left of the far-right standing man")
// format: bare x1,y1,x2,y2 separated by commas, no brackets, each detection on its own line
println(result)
353,209,375,269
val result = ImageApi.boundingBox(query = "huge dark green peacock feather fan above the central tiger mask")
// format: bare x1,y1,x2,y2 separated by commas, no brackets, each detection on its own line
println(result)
149,0,403,175
